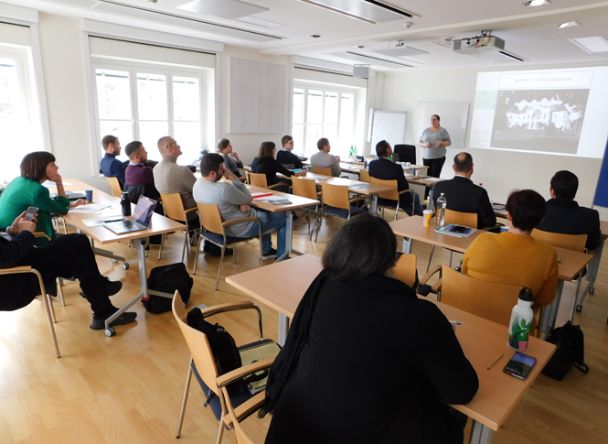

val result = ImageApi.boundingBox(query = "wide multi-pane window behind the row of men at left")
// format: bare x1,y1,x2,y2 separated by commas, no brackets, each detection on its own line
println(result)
94,63,207,163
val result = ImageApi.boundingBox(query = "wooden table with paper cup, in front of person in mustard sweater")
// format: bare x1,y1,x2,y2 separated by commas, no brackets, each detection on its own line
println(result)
389,216,593,335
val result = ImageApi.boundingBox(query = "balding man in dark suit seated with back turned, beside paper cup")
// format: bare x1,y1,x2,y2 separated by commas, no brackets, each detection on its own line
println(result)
433,152,496,228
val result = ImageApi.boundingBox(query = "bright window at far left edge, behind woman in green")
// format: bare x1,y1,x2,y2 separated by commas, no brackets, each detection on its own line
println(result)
0,45,46,181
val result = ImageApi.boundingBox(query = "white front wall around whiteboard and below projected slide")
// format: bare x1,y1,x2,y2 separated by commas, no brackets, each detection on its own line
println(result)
382,68,601,206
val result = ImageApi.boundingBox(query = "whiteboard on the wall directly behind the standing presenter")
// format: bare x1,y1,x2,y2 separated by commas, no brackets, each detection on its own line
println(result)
413,102,469,150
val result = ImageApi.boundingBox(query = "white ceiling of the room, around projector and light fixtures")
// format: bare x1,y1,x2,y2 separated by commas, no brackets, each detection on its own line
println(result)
3,0,608,70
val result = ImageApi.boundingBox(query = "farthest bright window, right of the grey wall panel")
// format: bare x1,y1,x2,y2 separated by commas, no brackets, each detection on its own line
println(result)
292,82,363,158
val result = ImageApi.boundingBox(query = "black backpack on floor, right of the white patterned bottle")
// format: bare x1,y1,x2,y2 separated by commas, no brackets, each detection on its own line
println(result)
543,321,589,381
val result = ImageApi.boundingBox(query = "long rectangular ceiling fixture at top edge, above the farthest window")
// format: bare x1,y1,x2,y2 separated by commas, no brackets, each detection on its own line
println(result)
300,0,414,24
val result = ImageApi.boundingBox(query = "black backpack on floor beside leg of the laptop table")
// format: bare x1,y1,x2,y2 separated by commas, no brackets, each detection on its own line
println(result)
142,262,194,314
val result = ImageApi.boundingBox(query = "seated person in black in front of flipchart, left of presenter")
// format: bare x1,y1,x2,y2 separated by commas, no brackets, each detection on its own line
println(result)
369,140,422,216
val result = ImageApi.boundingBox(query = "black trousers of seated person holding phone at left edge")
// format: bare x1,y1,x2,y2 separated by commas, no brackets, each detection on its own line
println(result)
0,234,115,317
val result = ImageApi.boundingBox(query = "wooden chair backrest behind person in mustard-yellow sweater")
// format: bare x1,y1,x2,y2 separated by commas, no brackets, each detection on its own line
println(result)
439,265,522,327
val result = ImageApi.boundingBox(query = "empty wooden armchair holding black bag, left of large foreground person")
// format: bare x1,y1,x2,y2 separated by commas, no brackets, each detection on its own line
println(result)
172,291,280,444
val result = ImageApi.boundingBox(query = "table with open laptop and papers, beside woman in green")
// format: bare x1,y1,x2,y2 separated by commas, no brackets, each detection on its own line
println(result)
57,179,186,336
